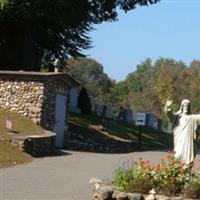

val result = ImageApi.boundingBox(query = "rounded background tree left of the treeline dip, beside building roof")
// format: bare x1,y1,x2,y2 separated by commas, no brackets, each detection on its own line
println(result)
66,57,115,105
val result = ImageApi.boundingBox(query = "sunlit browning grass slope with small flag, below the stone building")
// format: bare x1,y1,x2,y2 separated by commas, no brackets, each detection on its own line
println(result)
0,108,43,168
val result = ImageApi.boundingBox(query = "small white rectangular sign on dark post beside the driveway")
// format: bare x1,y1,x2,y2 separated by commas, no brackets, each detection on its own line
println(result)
135,113,146,148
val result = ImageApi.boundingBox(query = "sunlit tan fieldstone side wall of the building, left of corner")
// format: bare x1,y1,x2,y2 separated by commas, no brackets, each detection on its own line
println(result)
0,80,44,124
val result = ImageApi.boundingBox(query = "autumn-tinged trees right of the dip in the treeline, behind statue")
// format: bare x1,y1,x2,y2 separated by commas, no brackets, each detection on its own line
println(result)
113,58,200,120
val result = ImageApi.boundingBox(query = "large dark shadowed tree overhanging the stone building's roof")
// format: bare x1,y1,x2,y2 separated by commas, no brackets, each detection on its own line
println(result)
0,0,159,71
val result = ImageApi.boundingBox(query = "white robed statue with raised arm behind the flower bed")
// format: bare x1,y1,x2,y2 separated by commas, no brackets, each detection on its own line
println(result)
165,99,200,164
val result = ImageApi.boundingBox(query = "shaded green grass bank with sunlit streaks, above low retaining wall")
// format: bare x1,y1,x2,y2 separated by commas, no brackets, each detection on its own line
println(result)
69,113,172,150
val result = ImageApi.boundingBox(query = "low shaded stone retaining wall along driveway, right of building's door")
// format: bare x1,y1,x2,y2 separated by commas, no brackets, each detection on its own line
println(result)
64,123,138,153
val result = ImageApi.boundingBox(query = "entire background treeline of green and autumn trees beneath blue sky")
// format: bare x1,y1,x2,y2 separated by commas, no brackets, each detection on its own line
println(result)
67,58,200,123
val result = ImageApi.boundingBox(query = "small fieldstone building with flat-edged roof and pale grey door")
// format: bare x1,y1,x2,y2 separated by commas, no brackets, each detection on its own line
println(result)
0,71,79,147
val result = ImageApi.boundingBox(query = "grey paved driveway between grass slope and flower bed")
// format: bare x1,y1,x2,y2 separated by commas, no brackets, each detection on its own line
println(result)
0,151,199,200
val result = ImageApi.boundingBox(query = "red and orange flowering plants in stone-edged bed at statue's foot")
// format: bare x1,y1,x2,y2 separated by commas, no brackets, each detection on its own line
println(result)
114,153,200,196
